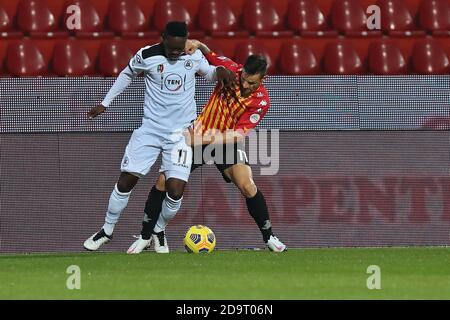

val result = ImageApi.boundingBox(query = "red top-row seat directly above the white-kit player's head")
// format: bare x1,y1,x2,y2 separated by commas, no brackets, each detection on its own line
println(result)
153,0,205,38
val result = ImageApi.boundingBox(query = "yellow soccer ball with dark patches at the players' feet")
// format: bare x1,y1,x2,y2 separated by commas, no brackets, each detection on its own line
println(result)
184,224,216,253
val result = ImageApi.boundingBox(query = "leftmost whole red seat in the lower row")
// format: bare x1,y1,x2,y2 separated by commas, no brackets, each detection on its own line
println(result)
6,41,48,77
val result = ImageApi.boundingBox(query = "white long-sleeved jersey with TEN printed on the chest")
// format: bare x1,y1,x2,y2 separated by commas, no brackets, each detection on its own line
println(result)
102,43,216,133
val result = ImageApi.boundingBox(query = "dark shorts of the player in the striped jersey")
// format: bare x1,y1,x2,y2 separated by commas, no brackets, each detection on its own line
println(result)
191,143,249,183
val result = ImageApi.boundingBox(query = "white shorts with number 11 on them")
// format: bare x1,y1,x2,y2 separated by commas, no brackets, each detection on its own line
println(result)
120,126,192,182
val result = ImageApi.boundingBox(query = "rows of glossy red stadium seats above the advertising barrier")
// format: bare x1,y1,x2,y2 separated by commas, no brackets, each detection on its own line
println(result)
0,0,450,76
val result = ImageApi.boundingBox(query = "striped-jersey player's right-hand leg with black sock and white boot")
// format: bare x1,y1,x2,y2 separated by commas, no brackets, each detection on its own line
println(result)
223,164,286,252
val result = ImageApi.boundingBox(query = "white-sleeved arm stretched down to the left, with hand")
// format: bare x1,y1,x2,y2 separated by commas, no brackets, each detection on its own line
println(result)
87,49,145,119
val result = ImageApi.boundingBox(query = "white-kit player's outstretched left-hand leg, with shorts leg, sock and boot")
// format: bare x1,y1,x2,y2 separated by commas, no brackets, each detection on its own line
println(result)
84,128,160,251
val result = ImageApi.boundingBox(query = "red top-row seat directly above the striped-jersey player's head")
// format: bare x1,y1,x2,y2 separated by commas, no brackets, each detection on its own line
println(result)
242,0,292,37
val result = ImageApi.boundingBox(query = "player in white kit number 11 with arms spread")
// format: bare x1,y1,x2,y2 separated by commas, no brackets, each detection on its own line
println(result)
84,21,235,251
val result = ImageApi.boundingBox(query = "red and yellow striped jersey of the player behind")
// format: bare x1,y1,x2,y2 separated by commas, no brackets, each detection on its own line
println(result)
194,52,270,134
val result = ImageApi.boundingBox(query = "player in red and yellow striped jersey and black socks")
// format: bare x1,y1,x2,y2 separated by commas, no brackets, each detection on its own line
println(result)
128,40,287,254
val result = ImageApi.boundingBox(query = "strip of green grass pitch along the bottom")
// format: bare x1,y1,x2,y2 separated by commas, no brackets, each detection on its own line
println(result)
0,248,450,300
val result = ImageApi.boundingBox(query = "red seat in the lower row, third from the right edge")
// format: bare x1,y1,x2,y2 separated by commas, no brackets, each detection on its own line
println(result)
324,41,364,74
